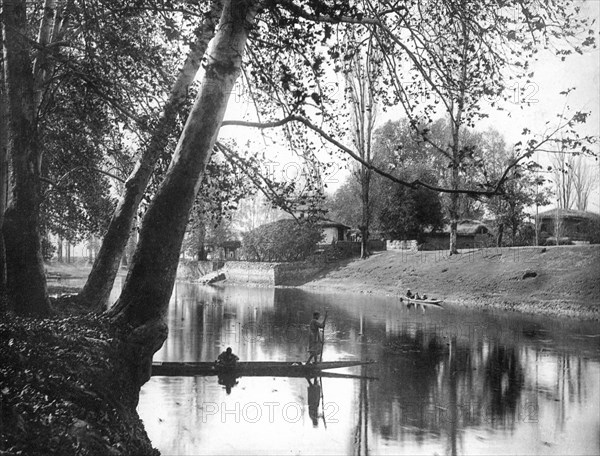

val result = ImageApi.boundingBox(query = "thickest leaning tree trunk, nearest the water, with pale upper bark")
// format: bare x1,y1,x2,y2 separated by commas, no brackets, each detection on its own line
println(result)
108,0,256,332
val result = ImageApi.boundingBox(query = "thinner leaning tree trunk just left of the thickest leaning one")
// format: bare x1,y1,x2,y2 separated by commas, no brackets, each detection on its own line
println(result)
79,1,221,309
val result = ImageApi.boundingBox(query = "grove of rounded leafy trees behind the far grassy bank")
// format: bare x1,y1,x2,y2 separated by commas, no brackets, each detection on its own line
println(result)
327,119,551,246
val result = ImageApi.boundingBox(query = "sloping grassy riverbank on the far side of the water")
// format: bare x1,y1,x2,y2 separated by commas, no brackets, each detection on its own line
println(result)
302,245,600,320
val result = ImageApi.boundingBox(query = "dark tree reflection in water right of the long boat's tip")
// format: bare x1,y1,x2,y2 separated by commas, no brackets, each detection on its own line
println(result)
370,330,523,454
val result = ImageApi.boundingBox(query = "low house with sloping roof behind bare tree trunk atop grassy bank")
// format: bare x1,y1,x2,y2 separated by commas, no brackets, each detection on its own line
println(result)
420,220,493,250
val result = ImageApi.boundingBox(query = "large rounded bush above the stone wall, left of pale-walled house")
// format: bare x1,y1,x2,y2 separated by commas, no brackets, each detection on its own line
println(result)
242,219,323,261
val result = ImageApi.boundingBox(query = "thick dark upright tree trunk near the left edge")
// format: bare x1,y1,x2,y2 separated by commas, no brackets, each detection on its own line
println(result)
2,0,50,315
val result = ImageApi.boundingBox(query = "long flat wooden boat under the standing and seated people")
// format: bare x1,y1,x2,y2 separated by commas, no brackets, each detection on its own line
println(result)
152,361,373,377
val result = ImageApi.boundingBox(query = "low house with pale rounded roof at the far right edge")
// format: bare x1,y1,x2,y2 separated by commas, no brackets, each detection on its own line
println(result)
537,209,600,244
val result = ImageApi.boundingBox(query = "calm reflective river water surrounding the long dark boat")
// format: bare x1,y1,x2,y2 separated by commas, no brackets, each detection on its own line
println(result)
138,284,600,455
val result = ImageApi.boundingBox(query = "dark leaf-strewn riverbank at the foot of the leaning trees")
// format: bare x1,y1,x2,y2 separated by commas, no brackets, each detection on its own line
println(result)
0,314,159,456
